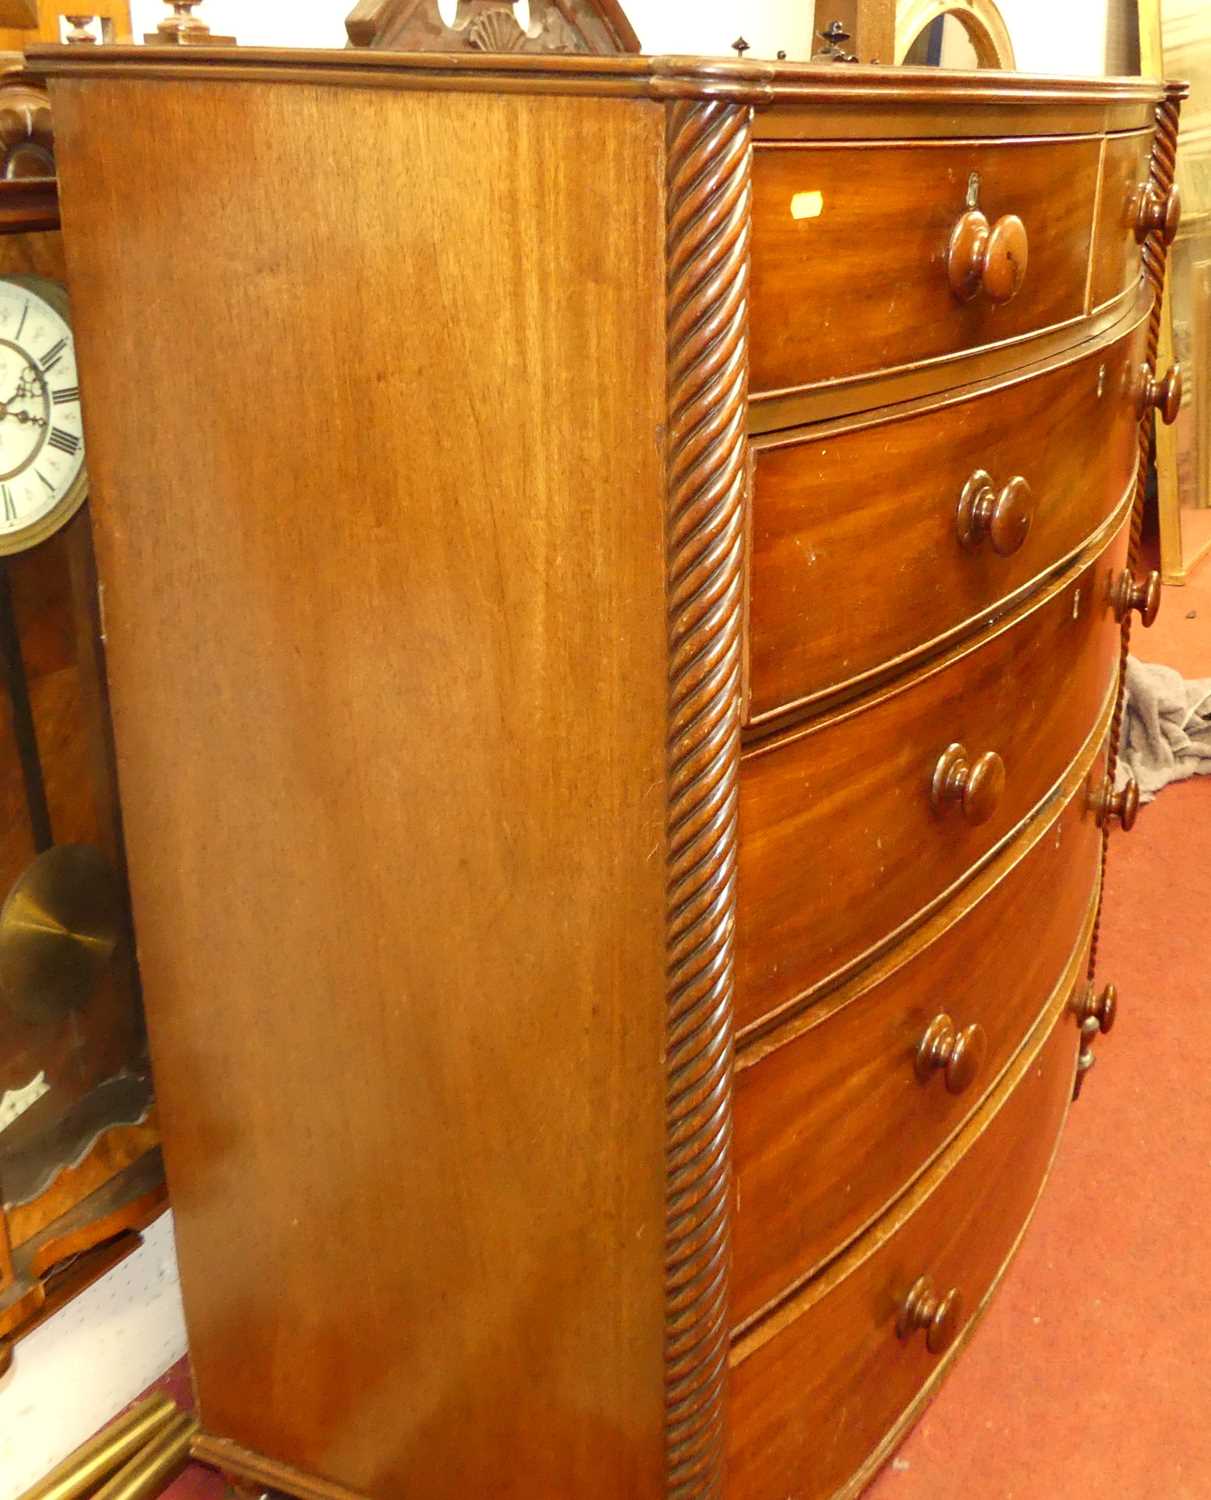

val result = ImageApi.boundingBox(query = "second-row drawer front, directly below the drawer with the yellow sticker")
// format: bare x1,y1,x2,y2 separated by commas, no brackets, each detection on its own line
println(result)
749,310,1146,720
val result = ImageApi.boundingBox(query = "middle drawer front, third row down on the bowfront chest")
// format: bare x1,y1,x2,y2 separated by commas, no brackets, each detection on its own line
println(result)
737,524,1127,1031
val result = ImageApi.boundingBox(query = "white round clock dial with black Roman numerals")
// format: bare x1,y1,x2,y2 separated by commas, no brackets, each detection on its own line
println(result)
0,278,86,552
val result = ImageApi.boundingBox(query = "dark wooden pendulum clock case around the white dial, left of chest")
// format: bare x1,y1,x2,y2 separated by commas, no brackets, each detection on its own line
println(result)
0,56,167,1373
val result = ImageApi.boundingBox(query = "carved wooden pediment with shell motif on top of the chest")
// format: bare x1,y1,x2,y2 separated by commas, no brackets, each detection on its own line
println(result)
345,0,639,56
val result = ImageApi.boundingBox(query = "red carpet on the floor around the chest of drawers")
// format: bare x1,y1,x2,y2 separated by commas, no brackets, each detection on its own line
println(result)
132,561,1211,1500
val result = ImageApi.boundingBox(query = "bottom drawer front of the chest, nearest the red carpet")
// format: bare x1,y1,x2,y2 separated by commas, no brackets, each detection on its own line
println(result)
728,996,1076,1500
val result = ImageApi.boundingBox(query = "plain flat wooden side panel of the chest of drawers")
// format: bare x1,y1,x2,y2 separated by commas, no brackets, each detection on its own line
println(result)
47,80,668,1500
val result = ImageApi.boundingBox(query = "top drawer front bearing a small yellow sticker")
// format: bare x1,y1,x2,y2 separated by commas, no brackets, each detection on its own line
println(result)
750,138,1101,393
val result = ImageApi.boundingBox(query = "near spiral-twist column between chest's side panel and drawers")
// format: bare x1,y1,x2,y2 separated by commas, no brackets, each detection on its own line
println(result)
665,101,752,1500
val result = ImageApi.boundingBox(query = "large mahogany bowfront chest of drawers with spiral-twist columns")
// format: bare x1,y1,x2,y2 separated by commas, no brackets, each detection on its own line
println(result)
41,48,1181,1500
